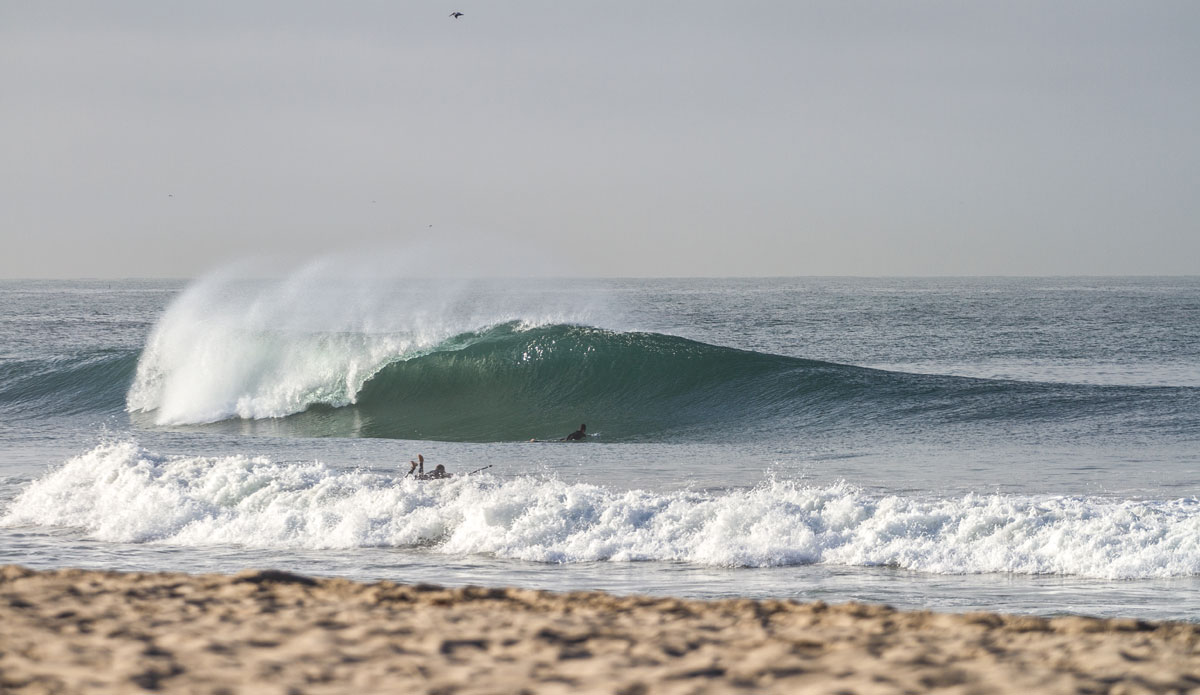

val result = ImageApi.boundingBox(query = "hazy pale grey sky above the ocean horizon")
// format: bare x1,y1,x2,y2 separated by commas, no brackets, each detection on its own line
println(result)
0,0,1200,277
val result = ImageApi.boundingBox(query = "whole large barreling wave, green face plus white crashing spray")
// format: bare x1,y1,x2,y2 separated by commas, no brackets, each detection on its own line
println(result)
114,263,1200,442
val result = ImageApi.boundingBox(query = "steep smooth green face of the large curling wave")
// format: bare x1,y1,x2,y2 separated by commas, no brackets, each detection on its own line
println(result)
353,324,852,441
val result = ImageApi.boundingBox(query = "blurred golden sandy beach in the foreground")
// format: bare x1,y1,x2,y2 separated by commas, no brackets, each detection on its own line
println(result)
0,565,1200,694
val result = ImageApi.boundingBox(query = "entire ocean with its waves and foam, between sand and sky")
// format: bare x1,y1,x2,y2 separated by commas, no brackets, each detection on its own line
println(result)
0,274,1200,621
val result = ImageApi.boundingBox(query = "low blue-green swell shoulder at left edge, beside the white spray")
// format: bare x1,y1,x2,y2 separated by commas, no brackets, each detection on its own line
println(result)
0,351,138,419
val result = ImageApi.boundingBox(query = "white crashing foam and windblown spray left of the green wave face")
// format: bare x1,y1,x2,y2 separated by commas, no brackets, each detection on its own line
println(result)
126,260,600,425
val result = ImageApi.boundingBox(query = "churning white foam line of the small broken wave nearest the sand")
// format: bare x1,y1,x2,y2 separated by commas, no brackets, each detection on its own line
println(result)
0,442,1200,579
